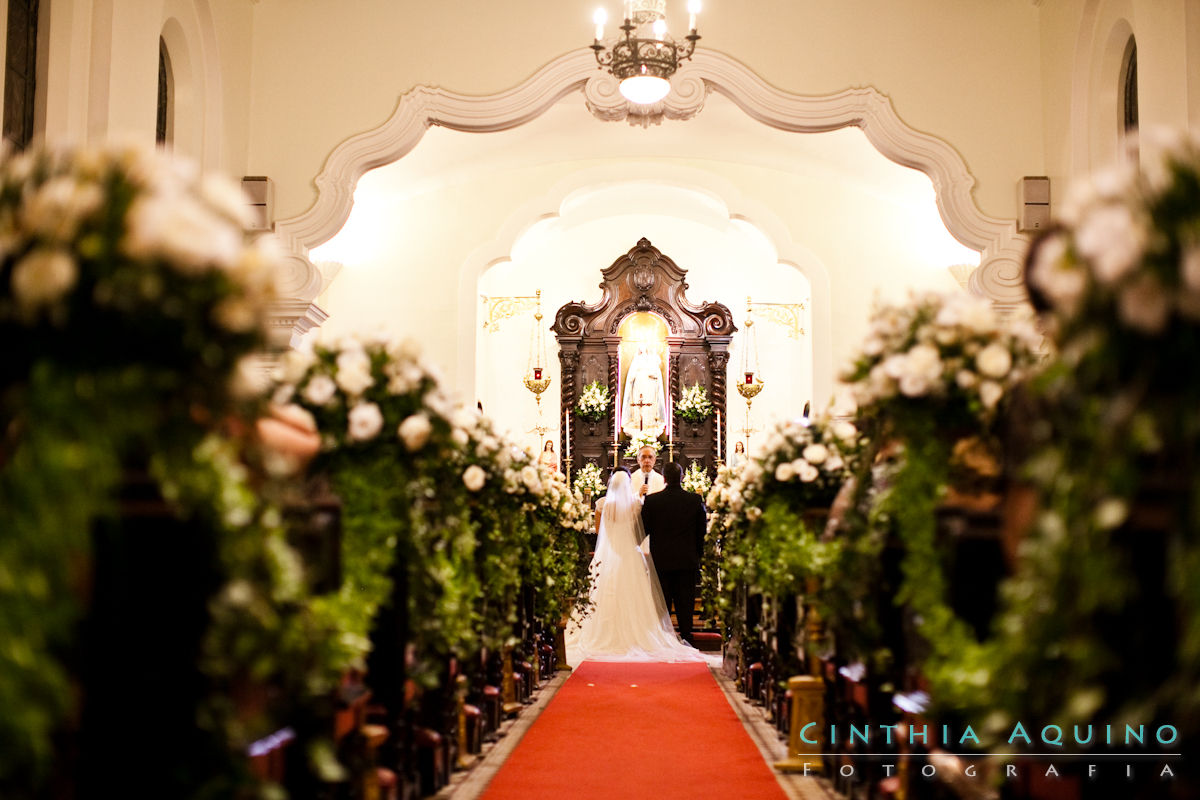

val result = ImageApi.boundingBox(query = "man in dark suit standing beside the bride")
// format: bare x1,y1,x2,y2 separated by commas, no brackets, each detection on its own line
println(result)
642,462,707,644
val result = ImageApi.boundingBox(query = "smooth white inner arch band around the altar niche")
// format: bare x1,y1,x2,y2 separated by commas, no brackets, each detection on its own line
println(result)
456,164,834,408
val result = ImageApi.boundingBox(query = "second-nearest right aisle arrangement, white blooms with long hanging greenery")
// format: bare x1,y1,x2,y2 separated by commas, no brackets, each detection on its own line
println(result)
842,293,1039,705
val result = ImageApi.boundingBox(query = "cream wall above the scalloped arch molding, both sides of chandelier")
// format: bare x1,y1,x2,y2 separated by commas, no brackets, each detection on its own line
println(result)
250,0,1043,225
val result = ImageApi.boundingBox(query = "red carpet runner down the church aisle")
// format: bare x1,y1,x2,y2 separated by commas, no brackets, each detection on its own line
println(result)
484,661,786,800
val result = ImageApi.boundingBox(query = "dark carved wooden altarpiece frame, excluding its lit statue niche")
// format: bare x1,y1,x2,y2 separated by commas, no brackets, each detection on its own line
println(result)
551,237,737,475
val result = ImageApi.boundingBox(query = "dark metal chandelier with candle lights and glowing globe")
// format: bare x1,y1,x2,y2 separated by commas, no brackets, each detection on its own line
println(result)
592,0,700,106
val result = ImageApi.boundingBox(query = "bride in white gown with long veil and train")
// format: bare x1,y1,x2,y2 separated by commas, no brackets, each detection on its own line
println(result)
568,468,704,664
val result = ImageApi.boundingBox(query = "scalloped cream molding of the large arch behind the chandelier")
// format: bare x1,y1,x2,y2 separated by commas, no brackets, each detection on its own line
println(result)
276,48,1028,316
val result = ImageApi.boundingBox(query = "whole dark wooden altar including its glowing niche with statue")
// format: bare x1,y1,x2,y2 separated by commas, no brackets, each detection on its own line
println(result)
551,237,737,474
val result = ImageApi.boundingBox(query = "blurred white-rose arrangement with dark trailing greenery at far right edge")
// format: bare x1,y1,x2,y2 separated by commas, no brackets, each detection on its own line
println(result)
966,139,1200,743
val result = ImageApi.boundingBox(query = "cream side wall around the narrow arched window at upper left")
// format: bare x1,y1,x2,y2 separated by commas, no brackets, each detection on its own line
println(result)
15,0,253,176
